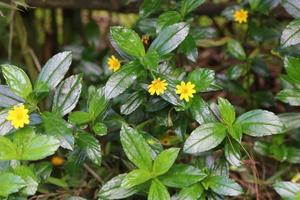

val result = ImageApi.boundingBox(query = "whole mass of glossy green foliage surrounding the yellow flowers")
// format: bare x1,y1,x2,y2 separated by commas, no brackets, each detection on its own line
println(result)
0,0,300,200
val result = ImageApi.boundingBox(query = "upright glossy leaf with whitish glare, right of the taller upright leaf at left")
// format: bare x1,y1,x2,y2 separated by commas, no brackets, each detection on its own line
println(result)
52,75,82,116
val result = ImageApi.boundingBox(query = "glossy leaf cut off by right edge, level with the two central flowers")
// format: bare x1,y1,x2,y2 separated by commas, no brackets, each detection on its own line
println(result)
276,89,300,106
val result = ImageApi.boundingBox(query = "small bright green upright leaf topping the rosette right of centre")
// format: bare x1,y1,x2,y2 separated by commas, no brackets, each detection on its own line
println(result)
218,97,235,126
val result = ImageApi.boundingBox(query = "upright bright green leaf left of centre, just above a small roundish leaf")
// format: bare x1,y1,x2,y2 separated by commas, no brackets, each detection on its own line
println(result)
88,88,108,120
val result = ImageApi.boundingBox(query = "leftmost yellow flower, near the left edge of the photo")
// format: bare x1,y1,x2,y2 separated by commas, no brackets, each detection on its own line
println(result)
6,104,29,129
